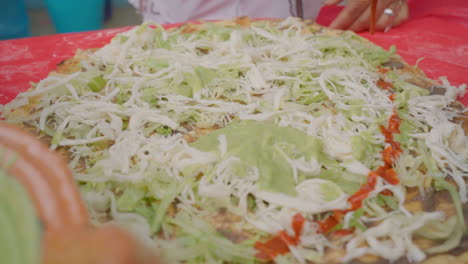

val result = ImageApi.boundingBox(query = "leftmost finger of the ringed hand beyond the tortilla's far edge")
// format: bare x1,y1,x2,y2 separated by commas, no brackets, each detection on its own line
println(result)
330,0,370,29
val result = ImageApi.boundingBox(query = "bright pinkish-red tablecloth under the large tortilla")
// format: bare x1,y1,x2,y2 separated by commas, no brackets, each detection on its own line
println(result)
0,0,468,106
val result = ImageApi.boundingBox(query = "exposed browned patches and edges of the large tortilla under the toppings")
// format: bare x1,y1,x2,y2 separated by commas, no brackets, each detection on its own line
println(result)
1,17,468,264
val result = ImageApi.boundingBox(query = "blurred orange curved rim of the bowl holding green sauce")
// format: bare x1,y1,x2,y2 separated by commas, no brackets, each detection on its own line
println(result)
0,122,88,231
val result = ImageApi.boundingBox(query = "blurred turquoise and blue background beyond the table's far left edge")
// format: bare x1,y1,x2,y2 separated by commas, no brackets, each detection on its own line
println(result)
0,0,142,40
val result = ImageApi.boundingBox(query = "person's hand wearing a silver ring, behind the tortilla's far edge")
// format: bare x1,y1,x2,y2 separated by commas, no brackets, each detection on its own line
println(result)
325,0,409,32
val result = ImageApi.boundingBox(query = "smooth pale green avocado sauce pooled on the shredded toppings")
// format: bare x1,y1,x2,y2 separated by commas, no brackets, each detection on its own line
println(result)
191,121,322,195
